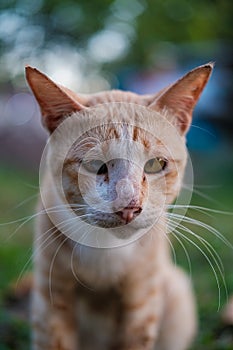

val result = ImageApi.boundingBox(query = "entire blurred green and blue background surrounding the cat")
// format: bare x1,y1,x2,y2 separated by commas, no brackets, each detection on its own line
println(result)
0,0,233,350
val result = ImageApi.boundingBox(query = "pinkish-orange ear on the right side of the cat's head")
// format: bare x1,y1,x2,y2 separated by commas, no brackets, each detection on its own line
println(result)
149,63,214,135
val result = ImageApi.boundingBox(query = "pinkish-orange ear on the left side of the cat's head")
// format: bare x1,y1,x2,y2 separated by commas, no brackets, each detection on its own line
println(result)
25,66,86,133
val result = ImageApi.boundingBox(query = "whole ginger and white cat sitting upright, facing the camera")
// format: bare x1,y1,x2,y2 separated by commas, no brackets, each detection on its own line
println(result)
26,63,213,350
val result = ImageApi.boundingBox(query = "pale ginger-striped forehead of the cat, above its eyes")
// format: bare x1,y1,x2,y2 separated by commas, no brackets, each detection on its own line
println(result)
48,102,185,164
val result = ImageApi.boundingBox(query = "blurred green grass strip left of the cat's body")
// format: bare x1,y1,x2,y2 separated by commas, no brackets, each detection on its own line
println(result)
0,167,38,350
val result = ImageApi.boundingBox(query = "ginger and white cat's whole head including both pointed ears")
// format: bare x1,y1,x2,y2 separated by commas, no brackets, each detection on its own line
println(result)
26,64,213,243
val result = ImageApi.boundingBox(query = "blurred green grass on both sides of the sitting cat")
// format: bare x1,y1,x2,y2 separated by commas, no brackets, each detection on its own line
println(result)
0,159,233,350
